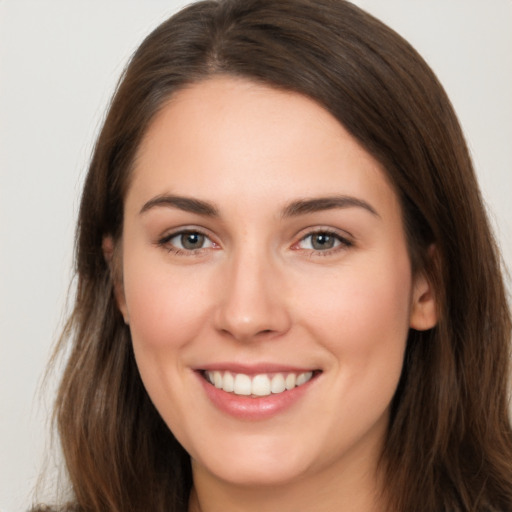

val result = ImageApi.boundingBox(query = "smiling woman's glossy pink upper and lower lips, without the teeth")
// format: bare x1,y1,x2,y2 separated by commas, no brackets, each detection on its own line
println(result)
196,364,320,421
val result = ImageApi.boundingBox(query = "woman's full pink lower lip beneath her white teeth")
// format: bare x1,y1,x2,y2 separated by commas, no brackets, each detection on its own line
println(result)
196,372,318,421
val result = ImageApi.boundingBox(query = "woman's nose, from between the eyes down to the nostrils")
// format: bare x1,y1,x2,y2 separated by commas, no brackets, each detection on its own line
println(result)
215,246,291,341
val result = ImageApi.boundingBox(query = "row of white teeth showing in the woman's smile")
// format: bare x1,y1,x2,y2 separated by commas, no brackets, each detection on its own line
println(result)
205,370,313,396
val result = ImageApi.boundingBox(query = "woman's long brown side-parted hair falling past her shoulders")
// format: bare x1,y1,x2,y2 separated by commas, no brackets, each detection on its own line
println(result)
34,0,512,512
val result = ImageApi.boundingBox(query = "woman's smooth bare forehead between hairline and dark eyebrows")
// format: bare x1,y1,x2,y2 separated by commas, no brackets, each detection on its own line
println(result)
131,77,400,218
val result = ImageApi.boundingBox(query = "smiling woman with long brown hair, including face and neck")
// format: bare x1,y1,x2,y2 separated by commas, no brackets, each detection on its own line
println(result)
33,0,512,512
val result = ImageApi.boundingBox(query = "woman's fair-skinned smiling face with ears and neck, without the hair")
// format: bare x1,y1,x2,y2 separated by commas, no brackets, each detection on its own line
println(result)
109,77,436,512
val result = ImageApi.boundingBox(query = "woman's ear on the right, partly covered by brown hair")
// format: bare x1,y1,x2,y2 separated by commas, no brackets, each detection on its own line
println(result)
409,246,438,331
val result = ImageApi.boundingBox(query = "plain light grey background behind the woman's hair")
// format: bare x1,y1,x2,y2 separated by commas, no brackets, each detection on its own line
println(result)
0,0,512,512
